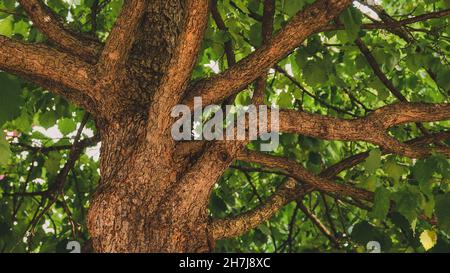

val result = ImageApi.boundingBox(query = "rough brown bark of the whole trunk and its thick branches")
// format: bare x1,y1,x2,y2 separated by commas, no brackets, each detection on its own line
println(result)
4,0,450,252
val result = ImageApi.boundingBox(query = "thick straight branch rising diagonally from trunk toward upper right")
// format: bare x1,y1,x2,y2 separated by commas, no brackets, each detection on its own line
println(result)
184,0,351,108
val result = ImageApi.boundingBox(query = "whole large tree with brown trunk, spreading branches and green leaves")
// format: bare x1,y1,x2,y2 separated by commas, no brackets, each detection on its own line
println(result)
0,0,450,252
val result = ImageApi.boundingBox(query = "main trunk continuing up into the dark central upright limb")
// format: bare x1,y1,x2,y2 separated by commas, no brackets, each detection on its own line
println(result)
88,0,211,252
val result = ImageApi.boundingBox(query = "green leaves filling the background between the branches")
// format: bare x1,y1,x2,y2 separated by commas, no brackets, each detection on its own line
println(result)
0,0,450,252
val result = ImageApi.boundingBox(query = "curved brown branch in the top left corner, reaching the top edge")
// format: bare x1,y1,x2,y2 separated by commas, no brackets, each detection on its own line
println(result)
19,0,101,61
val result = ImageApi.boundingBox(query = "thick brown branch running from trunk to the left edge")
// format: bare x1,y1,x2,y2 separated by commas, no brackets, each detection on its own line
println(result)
0,36,96,110
